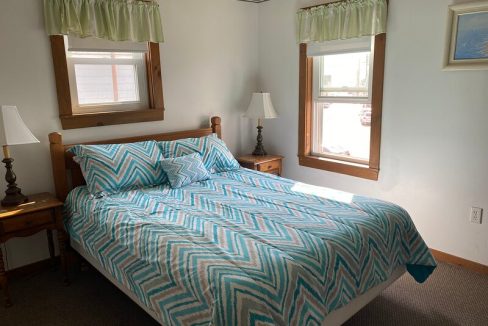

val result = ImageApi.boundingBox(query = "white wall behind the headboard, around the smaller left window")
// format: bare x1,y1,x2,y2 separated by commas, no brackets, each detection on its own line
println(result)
0,0,258,268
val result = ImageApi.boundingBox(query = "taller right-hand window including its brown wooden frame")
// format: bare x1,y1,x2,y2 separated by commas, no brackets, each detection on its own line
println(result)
299,34,385,180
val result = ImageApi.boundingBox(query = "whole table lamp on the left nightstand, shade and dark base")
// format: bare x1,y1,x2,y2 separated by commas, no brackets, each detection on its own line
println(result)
0,105,39,206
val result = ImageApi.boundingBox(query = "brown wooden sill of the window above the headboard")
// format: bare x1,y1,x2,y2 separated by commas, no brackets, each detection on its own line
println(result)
60,108,164,129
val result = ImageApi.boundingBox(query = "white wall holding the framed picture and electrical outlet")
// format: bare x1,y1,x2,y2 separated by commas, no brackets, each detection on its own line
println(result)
259,0,488,265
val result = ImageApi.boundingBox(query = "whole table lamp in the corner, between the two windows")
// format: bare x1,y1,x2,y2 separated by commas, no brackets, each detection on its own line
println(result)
245,93,278,156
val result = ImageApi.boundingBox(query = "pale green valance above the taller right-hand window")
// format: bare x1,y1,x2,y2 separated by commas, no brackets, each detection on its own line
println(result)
297,0,388,43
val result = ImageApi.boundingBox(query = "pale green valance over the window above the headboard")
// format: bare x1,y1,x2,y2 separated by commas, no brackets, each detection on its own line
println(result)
44,0,164,43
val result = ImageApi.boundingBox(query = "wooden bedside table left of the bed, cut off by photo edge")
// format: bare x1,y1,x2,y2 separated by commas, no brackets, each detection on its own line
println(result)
0,193,67,307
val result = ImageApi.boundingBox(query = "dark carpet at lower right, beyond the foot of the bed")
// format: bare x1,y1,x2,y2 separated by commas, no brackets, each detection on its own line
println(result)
345,264,488,326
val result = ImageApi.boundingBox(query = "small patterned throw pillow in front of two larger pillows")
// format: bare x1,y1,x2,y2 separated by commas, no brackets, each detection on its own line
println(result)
160,153,210,188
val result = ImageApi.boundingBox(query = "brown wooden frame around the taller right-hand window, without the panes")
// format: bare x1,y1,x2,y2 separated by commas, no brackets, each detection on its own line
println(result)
298,34,386,181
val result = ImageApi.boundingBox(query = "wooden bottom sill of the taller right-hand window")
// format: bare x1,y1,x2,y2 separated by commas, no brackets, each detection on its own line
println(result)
298,155,379,181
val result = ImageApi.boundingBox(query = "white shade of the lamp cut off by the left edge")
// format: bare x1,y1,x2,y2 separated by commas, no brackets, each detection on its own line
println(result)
0,105,39,145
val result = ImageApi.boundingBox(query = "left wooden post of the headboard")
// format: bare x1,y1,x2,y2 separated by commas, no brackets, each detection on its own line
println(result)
49,132,68,202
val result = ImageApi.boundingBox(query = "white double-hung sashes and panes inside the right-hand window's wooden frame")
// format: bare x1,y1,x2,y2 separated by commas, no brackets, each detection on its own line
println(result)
308,37,373,164
